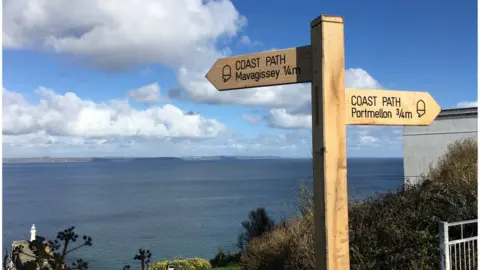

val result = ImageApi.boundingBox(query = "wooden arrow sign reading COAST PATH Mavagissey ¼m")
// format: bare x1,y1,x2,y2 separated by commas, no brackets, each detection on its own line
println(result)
205,46,312,91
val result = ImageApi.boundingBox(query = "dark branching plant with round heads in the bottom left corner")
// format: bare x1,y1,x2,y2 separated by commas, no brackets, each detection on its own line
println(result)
7,227,92,270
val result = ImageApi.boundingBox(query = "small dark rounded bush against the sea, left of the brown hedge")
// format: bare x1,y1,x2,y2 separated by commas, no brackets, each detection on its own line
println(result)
237,207,275,250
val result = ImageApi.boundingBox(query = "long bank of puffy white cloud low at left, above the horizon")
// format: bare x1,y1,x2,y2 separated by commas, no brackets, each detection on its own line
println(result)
3,87,226,139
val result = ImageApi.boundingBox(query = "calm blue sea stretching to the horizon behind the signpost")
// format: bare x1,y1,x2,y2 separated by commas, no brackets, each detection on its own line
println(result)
3,159,403,270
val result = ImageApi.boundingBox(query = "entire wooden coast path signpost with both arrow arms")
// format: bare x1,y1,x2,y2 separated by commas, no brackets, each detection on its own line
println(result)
206,15,441,270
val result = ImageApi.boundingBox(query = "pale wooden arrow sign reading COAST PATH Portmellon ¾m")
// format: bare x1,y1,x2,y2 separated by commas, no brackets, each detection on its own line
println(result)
345,88,441,126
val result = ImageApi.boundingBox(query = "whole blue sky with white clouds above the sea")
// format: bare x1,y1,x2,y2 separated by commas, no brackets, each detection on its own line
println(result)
2,0,478,157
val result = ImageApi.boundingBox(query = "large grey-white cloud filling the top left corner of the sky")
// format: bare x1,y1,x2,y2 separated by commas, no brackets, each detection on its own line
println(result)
3,0,246,69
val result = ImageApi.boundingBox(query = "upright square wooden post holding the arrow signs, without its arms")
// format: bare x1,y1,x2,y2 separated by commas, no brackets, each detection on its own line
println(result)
311,15,350,270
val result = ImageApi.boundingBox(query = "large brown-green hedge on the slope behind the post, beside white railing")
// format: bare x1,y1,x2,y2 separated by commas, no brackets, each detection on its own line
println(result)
241,140,478,270
